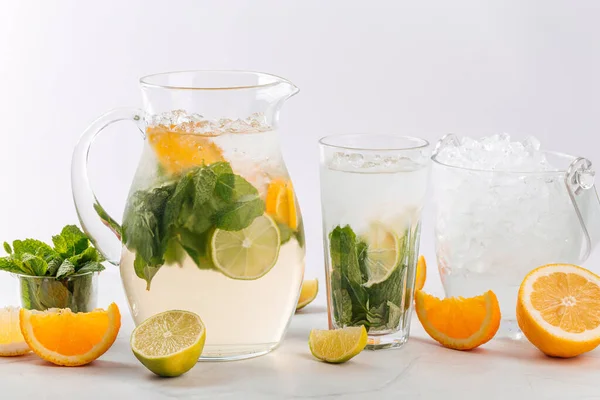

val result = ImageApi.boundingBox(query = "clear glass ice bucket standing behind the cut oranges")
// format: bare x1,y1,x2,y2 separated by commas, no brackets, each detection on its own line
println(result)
432,135,600,338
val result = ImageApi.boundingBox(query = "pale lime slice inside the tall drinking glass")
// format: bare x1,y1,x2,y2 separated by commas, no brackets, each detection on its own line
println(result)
363,222,405,287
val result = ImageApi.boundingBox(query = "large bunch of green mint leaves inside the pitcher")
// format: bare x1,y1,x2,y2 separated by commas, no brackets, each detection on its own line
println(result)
122,162,265,290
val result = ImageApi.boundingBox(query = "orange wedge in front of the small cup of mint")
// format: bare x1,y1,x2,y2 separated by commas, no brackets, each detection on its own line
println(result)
20,303,121,367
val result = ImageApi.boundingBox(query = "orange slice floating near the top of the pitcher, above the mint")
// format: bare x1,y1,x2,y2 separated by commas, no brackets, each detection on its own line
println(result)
146,126,224,174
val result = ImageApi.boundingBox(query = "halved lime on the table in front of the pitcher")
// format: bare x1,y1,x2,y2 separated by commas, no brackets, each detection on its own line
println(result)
131,310,206,376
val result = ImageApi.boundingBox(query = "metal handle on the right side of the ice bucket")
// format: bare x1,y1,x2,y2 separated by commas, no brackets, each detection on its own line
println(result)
565,157,600,263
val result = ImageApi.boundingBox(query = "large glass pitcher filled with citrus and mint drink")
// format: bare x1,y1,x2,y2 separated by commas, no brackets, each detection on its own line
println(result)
72,71,305,360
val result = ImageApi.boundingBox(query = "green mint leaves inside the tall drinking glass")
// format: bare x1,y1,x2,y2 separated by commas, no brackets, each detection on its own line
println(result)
329,225,407,330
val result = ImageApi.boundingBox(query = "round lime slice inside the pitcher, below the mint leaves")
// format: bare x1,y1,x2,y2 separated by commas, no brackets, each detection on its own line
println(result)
210,215,280,280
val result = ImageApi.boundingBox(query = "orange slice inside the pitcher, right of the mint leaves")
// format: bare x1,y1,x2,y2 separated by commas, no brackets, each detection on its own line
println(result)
266,179,298,230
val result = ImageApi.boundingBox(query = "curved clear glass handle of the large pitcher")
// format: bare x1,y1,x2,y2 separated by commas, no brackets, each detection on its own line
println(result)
71,108,144,265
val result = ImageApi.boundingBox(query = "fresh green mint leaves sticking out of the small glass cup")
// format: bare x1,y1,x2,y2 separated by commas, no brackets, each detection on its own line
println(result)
0,225,104,279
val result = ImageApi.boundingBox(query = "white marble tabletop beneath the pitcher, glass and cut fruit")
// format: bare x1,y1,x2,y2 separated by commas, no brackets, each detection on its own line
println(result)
0,296,600,400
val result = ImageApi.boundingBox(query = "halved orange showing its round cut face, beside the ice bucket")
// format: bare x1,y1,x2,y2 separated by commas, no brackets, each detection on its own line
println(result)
517,264,600,358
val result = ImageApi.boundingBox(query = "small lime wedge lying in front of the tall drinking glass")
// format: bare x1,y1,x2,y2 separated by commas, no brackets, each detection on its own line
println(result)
308,325,368,364
